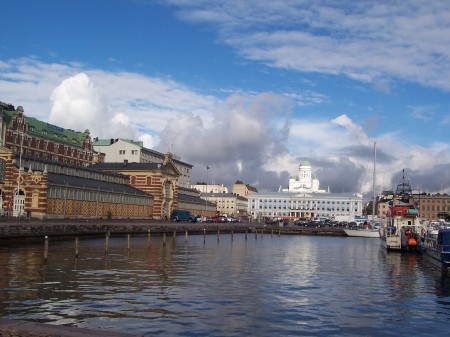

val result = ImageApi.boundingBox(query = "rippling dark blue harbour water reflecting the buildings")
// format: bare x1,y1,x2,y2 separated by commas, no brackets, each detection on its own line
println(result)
0,233,450,336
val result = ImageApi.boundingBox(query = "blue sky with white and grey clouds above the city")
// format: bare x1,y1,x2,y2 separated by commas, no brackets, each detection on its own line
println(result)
0,0,450,200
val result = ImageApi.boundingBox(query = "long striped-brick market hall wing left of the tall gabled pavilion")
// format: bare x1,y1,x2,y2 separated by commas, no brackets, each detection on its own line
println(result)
0,147,153,219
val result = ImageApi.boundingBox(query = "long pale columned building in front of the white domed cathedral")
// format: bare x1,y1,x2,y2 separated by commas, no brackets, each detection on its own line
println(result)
248,192,363,221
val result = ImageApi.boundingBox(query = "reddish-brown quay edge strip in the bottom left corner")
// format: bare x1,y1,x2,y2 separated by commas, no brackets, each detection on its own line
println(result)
0,318,140,337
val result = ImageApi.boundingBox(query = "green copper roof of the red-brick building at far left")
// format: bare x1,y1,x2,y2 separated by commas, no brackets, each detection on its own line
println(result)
4,106,89,148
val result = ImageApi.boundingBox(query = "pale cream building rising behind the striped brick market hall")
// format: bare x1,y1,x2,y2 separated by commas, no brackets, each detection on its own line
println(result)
93,138,193,188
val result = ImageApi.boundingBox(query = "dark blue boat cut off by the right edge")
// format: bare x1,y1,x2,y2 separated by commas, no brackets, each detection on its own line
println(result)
420,223,450,274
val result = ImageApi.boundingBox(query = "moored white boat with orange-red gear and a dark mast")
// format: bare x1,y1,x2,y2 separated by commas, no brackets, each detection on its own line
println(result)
380,170,426,253
